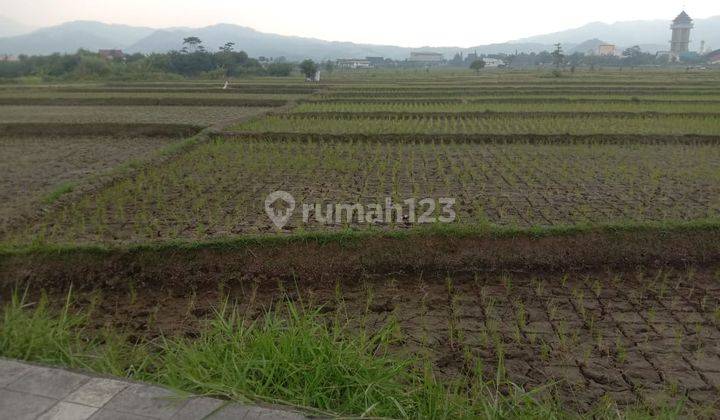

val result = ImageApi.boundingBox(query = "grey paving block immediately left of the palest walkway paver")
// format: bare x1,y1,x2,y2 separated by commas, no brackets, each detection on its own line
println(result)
6,367,88,400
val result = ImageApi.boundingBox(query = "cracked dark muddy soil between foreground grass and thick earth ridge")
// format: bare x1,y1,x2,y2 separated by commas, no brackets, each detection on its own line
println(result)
29,266,720,414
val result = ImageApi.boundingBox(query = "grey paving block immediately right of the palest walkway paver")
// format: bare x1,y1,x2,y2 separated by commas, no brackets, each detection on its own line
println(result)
105,384,187,419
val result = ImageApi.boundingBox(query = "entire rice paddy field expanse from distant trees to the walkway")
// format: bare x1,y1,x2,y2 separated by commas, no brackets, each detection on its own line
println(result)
0,70,720,418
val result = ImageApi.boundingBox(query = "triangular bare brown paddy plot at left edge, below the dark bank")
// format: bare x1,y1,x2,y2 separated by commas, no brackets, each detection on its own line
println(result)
0,136,179,232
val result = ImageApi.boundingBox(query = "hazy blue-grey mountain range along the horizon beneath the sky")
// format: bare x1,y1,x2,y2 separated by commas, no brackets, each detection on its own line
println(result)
0,16,720,60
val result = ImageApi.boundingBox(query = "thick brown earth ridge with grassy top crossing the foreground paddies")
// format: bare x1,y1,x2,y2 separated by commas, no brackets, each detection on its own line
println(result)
0,220,720,288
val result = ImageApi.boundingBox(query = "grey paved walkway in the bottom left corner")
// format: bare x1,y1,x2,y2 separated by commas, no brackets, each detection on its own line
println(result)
0,358,304,420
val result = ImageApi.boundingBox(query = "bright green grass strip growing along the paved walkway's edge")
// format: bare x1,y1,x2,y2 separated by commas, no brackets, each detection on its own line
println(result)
0,292,683,419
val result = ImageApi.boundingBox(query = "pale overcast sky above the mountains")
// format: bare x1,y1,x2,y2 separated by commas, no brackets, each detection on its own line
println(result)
0,0,720,47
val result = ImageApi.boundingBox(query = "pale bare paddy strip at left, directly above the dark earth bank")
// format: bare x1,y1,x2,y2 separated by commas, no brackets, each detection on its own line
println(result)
0,105,266,125
